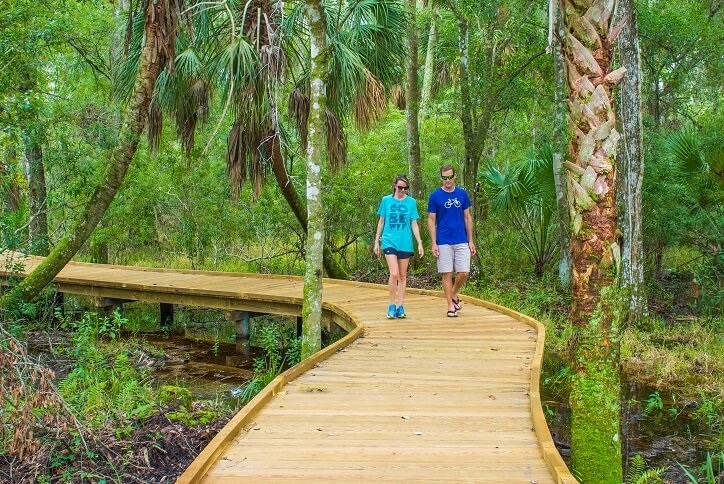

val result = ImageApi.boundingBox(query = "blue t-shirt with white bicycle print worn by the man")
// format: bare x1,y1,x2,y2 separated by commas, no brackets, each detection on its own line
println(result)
427,187,470,245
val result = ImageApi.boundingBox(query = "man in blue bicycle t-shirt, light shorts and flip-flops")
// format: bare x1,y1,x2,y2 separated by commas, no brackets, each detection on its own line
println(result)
427,165,476,318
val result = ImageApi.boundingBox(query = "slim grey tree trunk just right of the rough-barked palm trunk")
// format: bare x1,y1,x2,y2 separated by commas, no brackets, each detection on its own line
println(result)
613,0,646,324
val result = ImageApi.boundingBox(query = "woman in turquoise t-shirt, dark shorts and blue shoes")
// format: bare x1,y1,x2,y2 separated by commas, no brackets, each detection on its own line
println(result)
374,175,425,318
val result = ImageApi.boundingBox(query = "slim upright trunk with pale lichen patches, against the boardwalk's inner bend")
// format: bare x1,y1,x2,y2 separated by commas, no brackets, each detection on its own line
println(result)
302,0,328,358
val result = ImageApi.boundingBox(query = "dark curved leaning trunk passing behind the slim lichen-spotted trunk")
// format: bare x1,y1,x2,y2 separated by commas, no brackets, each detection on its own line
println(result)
264,134,349,279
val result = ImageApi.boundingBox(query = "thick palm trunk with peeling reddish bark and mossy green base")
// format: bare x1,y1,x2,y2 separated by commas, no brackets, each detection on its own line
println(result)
562,0,624,482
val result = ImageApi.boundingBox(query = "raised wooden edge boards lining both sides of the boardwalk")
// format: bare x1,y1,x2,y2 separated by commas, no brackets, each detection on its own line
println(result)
0,250,577,483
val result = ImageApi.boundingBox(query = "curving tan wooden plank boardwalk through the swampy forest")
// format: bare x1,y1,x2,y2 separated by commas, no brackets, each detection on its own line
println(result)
0,255,576,483
